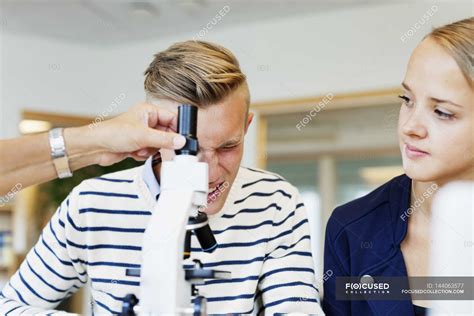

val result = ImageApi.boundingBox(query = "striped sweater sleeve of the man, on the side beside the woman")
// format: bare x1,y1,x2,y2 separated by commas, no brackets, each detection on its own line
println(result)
257,187,324,315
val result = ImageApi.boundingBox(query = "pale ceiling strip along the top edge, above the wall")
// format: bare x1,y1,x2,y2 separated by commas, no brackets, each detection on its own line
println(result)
0,0,385,45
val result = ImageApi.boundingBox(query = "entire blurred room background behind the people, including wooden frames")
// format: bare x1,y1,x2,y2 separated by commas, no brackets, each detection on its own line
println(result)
0,0,473,314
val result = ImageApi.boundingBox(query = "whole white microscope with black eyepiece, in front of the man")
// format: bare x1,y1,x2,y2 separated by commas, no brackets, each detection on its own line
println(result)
121,104,230,316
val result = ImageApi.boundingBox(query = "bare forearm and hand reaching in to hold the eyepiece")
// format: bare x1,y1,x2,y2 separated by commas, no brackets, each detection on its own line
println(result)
0,103,186,195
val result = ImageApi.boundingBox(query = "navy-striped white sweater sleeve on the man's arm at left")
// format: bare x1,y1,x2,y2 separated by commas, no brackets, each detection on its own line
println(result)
0,193,87,315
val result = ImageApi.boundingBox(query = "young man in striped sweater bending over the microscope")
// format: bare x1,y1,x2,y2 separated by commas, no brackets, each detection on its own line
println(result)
1,41,322,314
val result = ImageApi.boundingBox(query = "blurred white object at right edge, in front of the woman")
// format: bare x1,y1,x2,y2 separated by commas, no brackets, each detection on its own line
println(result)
429,182,474,316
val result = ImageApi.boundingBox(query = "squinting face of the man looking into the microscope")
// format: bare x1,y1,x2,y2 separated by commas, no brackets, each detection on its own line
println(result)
153,85,253,215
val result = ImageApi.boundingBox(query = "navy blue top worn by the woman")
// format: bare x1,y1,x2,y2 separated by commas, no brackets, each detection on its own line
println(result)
323,175,415,316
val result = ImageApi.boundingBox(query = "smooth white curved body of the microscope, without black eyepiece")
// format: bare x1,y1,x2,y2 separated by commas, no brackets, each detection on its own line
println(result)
140,155,208,315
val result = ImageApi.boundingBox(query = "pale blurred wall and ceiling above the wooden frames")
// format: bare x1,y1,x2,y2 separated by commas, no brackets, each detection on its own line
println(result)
0,0,466,138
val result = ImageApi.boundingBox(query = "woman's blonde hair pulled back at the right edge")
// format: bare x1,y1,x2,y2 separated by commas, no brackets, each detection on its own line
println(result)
425,17,474,87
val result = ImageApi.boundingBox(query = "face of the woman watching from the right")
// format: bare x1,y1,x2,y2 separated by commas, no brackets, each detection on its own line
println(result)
398,38,474,183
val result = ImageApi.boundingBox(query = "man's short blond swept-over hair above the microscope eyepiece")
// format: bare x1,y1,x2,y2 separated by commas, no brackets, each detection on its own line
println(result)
145,41,248,107
